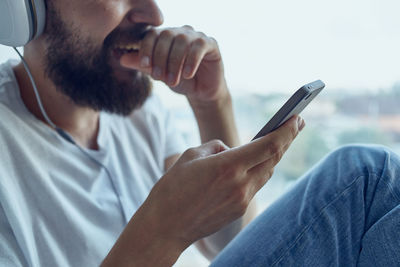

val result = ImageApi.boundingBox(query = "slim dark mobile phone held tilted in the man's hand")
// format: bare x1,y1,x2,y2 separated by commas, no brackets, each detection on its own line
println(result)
252,80,325,141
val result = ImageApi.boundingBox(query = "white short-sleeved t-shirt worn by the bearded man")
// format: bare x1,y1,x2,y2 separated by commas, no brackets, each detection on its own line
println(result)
0,62,185,266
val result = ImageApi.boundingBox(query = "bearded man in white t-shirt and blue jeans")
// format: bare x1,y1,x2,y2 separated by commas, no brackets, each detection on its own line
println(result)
0,0,400,266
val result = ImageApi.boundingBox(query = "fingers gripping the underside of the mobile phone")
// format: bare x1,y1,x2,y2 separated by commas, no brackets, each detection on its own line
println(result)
223,116,304,171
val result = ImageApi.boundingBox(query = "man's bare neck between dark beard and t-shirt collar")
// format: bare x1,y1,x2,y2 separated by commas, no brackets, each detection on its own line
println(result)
13,48,99,149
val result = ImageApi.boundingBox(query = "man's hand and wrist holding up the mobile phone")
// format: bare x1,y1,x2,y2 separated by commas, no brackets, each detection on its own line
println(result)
101,116,304,266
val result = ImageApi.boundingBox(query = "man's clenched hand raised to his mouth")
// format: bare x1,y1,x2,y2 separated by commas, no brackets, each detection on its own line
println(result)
120,26,227,102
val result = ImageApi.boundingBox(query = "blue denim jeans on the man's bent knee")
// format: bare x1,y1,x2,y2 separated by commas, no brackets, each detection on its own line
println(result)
211,146,400,267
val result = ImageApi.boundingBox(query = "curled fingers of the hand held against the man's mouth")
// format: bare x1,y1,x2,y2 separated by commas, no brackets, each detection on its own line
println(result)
120,26,219,86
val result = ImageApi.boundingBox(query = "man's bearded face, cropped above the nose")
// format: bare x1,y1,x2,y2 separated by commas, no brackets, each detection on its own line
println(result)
43,0,162,115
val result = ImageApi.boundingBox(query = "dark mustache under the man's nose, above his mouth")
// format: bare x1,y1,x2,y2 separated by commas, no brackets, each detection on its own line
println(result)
103,23,152,50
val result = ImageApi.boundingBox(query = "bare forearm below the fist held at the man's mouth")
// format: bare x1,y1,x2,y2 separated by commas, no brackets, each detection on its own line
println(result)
188,89,240,147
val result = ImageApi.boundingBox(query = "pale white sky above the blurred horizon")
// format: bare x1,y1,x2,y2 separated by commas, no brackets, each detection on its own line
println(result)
0,0,400,93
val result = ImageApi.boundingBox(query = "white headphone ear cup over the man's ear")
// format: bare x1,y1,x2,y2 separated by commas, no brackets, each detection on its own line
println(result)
0,0,46,47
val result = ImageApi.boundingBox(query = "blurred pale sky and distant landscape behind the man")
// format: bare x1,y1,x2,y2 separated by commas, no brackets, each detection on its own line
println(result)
0,0,400,267
